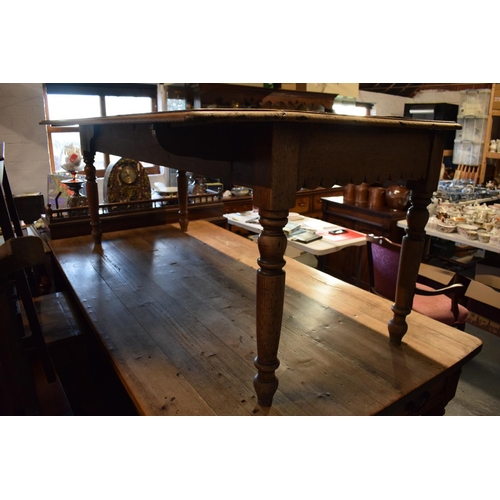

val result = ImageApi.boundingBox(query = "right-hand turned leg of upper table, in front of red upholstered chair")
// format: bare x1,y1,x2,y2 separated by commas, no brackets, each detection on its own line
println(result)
388,192,431,345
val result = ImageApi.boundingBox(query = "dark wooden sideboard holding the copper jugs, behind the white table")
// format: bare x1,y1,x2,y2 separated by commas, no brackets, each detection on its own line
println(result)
322,196,406,290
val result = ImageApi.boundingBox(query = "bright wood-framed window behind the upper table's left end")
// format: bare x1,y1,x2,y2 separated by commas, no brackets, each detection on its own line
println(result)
44,83,160,177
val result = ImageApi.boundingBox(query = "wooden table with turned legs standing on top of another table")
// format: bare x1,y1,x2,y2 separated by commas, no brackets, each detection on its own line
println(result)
42,109,460,406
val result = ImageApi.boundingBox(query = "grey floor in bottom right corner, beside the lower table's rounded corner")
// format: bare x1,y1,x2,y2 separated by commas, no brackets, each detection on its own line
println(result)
446,323,500,416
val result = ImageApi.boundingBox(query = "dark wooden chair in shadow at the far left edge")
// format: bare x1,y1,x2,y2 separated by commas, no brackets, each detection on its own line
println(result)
0,143,56,414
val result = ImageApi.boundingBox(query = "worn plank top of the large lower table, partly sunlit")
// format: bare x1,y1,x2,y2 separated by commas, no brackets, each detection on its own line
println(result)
50,221,481,415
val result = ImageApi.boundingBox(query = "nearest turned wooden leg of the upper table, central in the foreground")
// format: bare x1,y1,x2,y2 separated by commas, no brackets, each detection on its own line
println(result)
253,209,288,406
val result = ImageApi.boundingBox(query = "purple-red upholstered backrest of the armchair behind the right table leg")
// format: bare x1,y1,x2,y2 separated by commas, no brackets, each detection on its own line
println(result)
366,234,401,300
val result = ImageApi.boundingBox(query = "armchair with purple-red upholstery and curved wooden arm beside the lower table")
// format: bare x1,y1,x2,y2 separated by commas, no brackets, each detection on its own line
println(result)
366,234,468,330
